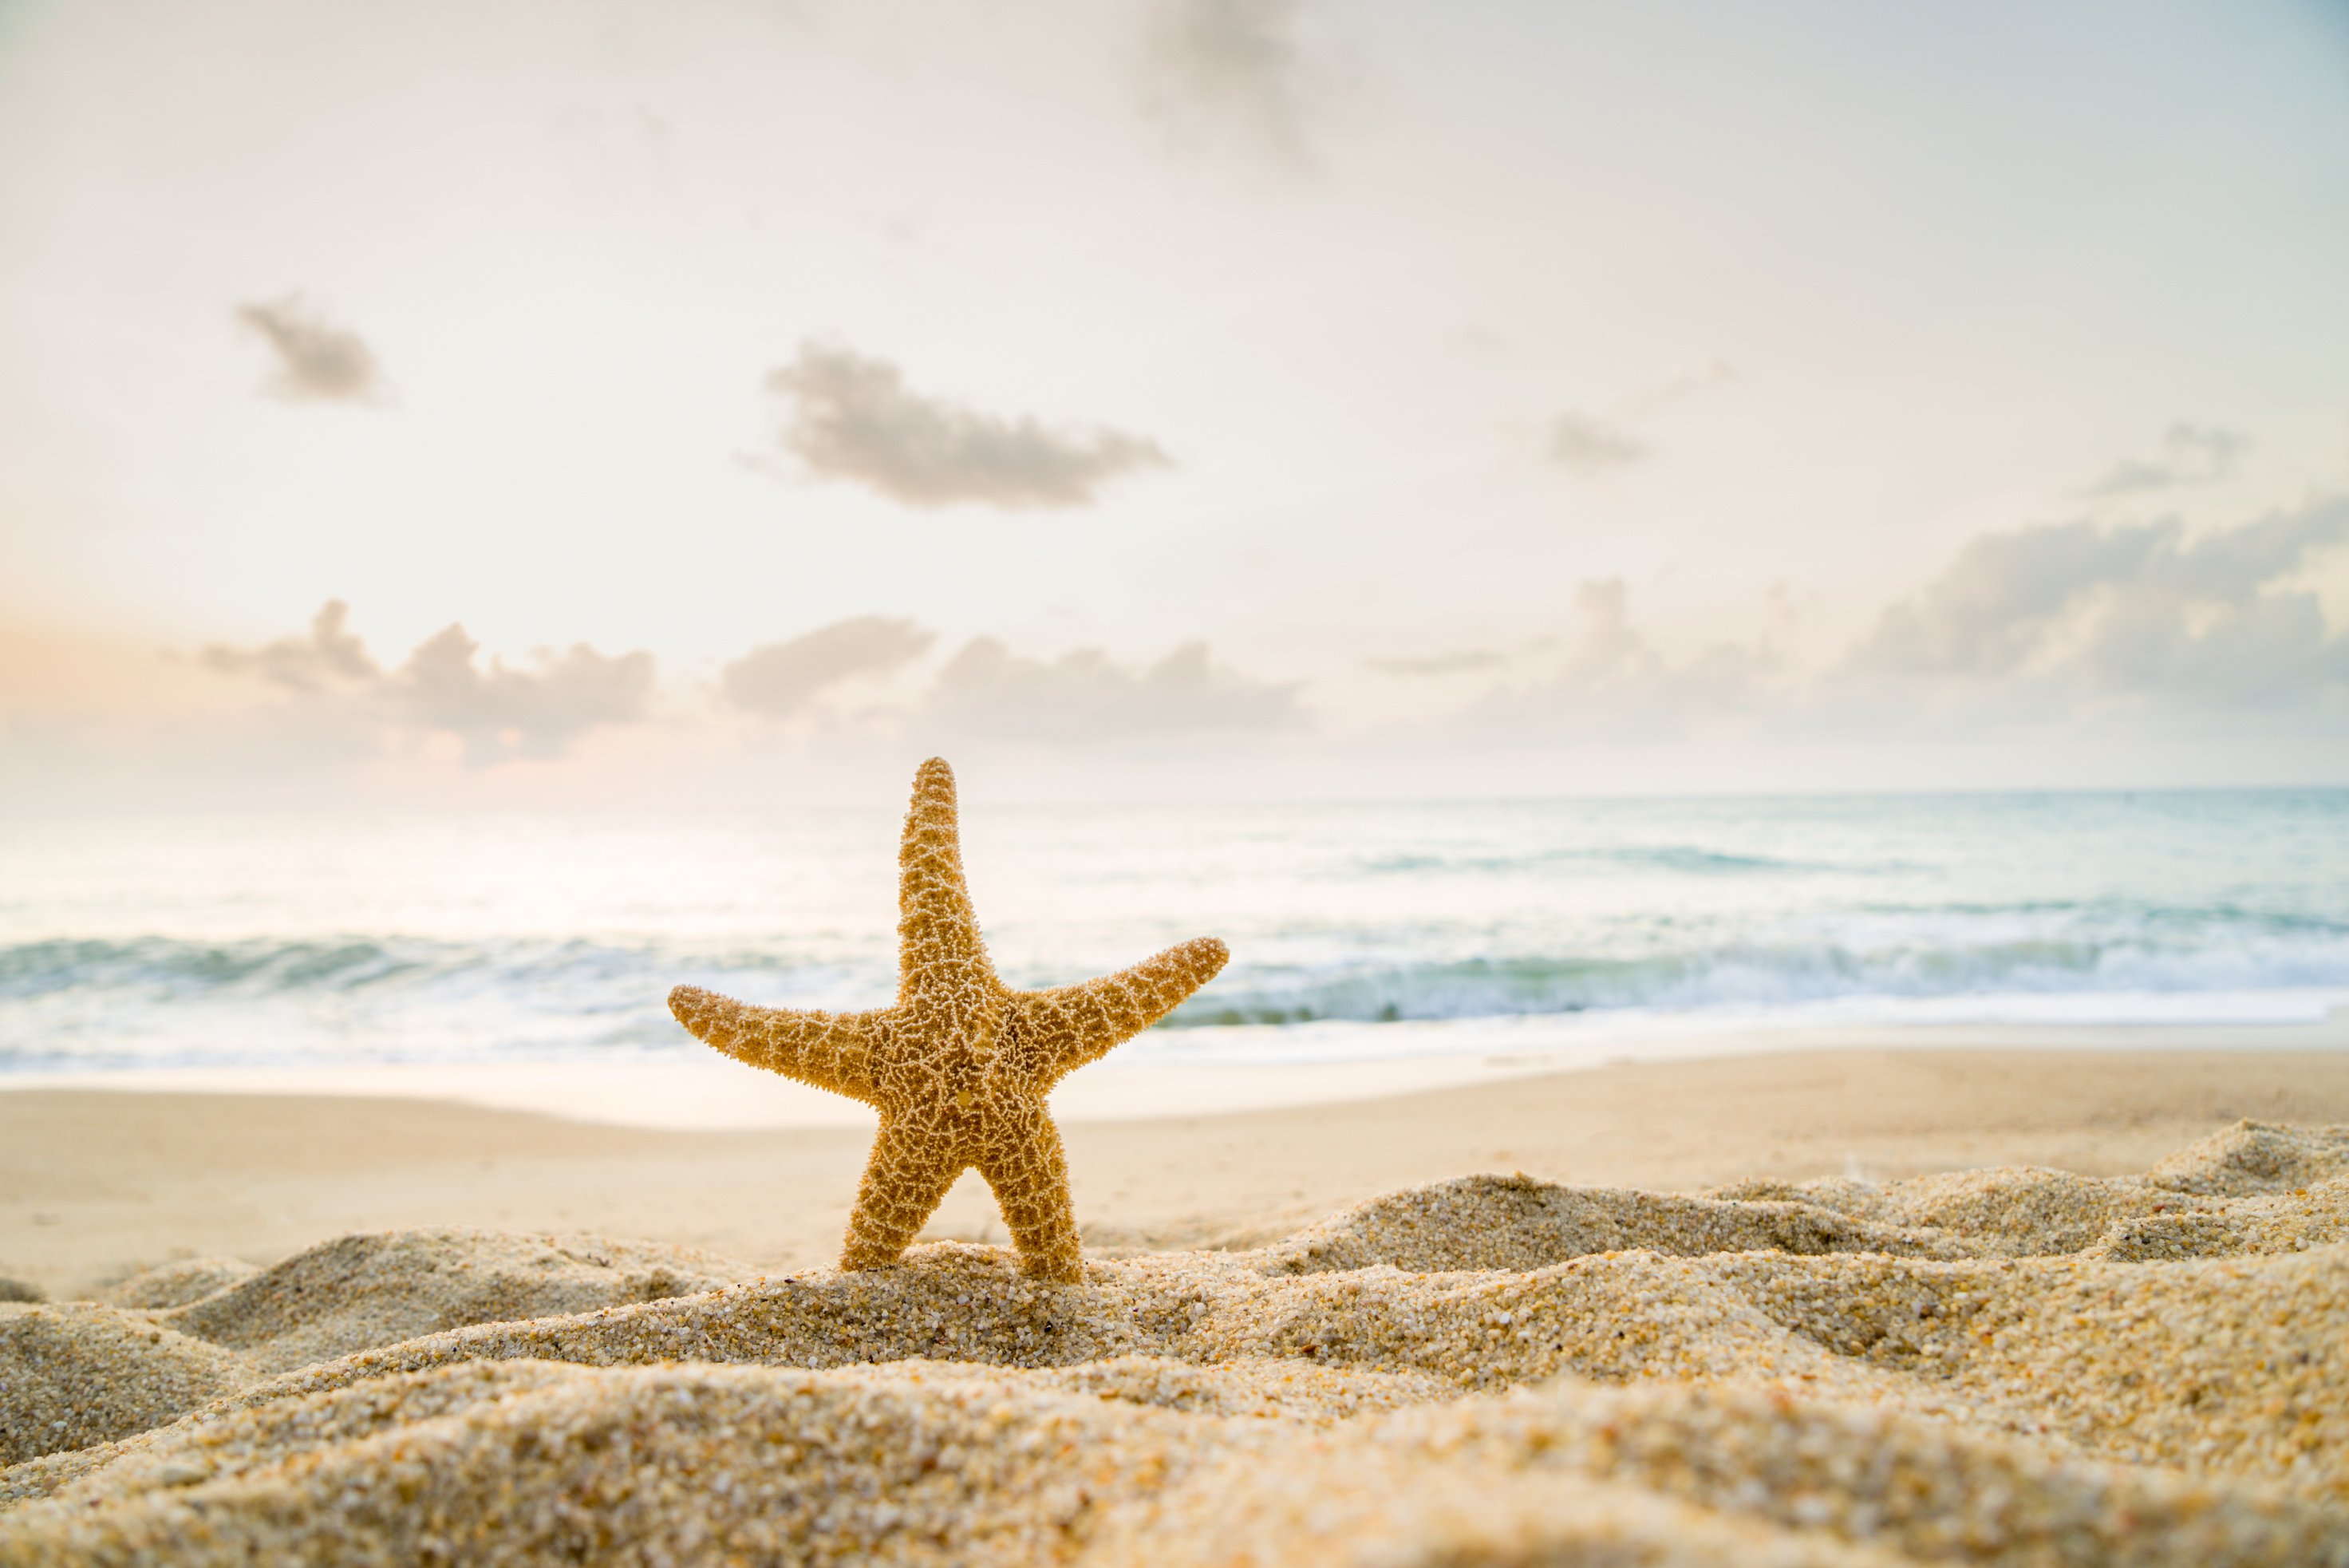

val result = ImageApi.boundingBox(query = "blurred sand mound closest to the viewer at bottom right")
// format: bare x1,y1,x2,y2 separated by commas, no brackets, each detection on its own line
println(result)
1099,1384,2349,1566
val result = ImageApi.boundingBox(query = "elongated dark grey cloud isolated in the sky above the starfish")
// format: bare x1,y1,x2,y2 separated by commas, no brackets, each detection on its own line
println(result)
766,343,1172,508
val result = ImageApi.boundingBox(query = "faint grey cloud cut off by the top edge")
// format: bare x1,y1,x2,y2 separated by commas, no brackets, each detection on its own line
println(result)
1139,0,1318,172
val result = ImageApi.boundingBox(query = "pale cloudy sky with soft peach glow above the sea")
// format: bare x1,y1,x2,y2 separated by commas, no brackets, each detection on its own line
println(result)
0,0,2349,806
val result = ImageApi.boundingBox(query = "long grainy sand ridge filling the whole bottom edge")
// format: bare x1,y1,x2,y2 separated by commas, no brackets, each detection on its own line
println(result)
0,1361,2349,1566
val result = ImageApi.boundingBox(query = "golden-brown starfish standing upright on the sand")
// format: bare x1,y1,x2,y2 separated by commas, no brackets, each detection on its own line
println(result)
669,757,1231,1282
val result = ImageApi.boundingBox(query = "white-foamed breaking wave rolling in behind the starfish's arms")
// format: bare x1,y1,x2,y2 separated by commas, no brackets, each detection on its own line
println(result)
0,907,2349,1069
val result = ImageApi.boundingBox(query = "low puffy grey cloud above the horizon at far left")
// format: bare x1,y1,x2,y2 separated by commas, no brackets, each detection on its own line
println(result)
199,599,653,762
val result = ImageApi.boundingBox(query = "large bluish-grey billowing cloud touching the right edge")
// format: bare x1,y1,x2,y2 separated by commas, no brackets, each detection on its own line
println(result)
1846,496,2349,705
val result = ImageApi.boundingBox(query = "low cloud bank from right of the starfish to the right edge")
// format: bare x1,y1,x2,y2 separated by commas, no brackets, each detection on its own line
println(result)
1369,496,2349,741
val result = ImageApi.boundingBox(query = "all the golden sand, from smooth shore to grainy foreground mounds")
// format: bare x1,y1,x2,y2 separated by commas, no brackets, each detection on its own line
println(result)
0,1056,2349,1563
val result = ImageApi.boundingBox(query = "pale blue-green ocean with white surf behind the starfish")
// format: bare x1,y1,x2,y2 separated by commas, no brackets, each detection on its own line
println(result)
0,790,2349,1074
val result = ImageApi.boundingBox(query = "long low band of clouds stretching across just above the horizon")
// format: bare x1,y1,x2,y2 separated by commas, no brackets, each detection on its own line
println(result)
133,496,2349,771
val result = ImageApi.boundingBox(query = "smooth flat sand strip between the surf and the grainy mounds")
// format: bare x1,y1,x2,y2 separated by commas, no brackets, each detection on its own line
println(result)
14,1018,2349,1293
